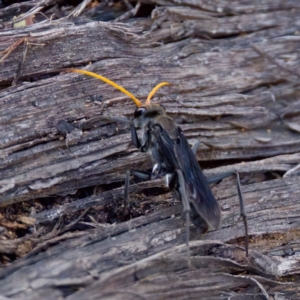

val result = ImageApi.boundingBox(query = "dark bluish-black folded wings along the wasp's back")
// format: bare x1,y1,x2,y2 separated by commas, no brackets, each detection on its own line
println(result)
155,127,221,232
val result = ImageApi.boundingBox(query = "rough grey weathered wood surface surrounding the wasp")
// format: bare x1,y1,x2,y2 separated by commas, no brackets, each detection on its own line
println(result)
0,0,300,299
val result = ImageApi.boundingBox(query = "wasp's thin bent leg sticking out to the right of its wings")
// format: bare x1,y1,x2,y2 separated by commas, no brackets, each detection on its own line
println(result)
207,172,249,256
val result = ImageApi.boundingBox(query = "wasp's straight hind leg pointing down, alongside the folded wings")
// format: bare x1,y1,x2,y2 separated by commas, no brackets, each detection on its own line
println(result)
176,169,192,267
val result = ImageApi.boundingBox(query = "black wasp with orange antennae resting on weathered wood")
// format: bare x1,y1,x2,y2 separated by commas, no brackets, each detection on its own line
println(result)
66,69,249,255
